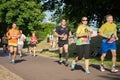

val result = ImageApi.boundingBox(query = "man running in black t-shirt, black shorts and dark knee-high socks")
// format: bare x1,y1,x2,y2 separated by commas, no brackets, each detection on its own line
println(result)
55,19,72,66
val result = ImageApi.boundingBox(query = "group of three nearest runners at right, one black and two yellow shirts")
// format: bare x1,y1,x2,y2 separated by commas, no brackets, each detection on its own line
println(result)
55,14,118,74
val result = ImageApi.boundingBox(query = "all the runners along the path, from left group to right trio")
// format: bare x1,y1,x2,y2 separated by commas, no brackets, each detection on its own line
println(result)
2,14,118,74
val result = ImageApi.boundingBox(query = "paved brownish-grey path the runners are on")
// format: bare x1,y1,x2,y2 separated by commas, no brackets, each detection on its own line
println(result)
0,52,120,80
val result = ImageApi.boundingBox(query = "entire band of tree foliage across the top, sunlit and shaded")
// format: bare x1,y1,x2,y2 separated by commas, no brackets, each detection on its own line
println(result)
0,0,120,35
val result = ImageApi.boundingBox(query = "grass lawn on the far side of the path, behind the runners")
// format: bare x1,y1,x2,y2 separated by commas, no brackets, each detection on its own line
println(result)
37,36,120,68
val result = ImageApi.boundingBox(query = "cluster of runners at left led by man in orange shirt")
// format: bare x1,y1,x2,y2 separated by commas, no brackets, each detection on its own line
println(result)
1,23,38,64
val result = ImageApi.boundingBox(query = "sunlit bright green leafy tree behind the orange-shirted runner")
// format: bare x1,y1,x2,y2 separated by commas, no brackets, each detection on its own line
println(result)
0,0,45,33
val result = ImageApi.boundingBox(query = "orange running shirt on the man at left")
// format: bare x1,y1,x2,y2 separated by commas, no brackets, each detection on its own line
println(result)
7,29,20,46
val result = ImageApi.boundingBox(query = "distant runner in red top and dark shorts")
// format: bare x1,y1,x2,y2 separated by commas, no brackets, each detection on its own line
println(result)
30,33,38,56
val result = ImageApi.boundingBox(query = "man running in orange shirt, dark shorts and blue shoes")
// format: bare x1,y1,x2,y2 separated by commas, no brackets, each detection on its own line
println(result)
6,23,20,64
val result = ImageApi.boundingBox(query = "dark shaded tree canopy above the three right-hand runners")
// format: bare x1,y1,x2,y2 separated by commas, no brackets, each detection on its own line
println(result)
43,0,120,30
